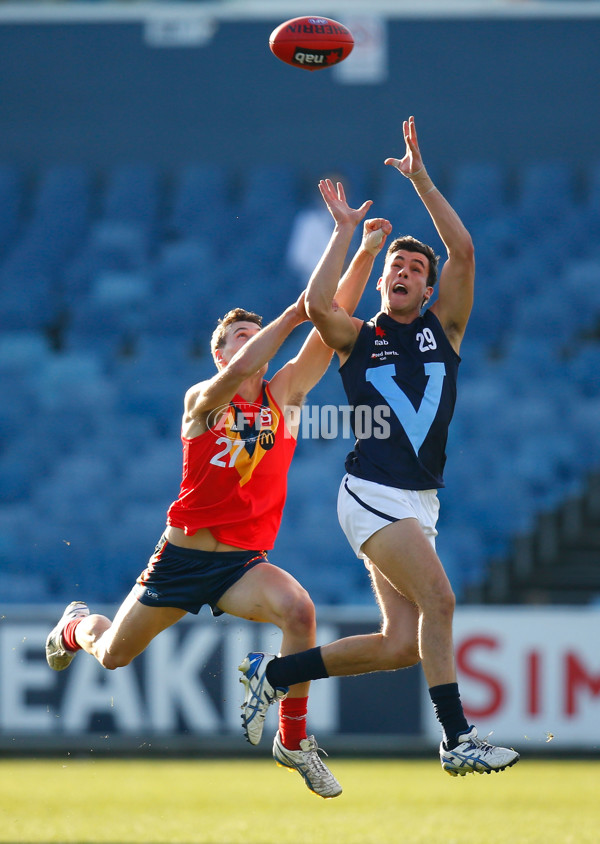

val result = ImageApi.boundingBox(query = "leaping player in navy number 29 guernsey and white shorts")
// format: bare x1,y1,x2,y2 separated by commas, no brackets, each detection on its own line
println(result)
240,117,519,776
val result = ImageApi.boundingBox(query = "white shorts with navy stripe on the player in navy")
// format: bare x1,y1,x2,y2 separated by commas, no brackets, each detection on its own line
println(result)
338,475,440,559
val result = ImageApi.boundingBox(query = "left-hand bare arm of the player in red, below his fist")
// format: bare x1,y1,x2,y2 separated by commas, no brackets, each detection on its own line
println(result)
183,292,307,436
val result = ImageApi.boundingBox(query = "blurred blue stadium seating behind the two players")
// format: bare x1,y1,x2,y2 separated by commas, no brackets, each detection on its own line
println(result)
0,162,600,603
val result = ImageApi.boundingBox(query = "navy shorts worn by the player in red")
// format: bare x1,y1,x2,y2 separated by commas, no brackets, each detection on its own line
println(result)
134,536,269,616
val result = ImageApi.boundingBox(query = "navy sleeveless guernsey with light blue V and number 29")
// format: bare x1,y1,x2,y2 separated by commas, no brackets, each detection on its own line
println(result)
339,311,460,490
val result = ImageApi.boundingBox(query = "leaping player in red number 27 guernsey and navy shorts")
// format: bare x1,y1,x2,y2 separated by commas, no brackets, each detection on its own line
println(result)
46,188,391,797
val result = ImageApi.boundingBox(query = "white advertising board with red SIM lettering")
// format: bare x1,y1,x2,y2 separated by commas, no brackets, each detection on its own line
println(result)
424,606,600,750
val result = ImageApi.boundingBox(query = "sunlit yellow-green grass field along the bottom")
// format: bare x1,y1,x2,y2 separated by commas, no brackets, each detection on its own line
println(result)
0,759,600,844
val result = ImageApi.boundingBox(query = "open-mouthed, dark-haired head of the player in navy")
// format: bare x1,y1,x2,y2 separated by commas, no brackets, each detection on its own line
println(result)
377,249,433,314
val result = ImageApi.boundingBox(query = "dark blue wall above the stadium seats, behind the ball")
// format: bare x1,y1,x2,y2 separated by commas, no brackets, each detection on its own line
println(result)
0,0,600,171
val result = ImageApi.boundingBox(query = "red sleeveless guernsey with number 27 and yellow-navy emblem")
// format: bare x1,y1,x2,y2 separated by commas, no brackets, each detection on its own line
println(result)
167,381,296,551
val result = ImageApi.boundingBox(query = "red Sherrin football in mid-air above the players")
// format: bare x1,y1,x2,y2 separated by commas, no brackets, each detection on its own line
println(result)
269,17,354,70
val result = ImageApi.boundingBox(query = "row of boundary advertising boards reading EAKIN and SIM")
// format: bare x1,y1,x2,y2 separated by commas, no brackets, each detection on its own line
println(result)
0,605,600,755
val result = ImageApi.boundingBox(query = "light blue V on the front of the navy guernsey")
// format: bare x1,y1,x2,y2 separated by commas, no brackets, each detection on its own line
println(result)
365,362,446,454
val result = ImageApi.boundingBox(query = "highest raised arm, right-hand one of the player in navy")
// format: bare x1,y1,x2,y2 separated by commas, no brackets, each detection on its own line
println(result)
385,117,475,351
